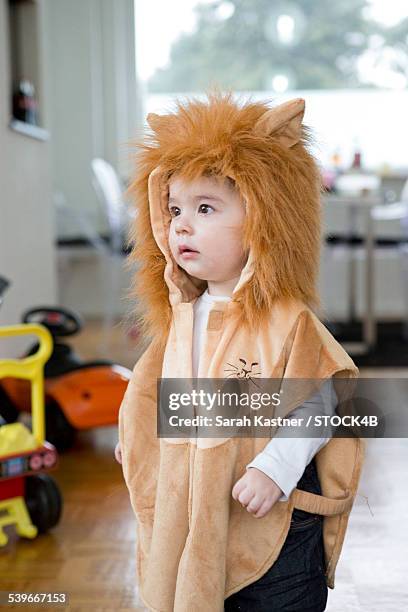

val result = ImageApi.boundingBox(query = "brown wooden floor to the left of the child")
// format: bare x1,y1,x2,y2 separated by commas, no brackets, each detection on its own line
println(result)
0,322,144,612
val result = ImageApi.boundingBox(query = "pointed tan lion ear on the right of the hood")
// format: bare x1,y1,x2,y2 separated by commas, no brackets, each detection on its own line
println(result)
254,98,305,148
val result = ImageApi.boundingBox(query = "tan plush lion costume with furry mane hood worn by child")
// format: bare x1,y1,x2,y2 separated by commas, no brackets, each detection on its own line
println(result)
119,93,364,612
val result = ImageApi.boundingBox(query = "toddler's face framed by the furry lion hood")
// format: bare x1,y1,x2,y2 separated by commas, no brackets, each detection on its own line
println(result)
169,176,246,282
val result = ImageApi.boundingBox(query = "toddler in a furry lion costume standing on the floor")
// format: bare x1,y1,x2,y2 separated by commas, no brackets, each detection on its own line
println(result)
115,94,363,612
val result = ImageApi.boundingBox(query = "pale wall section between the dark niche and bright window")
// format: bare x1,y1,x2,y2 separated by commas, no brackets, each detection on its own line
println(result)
41,0,141,236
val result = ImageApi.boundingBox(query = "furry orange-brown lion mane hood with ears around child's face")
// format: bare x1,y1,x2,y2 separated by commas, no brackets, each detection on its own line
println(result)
129,93,321,350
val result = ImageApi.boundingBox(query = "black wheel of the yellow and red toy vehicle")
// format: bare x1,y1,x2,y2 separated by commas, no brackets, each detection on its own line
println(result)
25,473,62,533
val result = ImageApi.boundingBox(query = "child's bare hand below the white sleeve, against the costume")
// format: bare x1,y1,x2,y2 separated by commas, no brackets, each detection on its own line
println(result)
232,467,283,518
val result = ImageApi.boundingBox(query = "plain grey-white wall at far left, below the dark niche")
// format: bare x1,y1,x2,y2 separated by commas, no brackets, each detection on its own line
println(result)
0,0,57,352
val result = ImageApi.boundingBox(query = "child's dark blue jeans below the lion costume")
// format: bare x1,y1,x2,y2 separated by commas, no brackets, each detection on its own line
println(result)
224,458,328,612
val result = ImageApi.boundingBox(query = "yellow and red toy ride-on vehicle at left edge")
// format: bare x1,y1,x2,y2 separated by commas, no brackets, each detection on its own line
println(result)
0,324,62,546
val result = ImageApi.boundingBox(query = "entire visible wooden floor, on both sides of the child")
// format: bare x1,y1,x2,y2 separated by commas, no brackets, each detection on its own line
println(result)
0,322,408,612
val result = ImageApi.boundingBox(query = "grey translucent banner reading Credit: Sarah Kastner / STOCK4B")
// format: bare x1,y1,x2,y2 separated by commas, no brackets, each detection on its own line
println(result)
157,377,408,438
